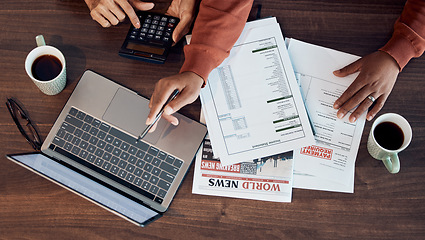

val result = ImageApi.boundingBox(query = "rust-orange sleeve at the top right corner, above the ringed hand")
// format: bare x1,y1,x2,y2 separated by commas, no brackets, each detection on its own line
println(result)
379,0,425,71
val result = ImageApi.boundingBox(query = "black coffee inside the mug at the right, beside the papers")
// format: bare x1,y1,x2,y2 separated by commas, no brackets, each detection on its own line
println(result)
373,122,404,150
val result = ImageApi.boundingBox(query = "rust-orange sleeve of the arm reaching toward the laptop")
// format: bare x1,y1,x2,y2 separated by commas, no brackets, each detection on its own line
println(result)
180,0,253,85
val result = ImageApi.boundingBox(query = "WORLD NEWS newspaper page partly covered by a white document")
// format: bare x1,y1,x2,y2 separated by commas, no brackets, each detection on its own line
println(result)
192,134,293,202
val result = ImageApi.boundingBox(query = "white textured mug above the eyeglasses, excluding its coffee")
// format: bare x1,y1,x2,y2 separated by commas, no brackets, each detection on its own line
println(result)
25,35,66,95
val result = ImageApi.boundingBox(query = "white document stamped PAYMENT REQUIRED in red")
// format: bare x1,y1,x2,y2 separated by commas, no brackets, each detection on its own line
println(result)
287,39,366,193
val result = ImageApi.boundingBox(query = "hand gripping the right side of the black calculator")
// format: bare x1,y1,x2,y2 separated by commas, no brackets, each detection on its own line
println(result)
166,0,198,43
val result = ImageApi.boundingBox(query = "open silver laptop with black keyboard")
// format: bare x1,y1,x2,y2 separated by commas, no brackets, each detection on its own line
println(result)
7,70,207,226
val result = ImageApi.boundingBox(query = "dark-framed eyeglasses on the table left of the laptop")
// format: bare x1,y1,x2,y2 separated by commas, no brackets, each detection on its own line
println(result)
6,98,42,151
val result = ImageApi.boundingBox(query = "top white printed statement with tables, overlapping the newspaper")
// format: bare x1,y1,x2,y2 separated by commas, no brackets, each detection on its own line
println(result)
201,18,315,166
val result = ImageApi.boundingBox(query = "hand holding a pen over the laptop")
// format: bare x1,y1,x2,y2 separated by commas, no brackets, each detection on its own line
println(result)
146,72,204,132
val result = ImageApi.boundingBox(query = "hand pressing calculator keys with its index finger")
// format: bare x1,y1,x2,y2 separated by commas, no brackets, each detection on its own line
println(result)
85,0,154,28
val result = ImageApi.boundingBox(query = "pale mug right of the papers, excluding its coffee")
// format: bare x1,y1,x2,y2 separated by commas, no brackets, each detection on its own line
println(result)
367,113,412,173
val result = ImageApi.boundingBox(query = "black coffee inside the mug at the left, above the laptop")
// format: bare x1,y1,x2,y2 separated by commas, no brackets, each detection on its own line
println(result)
31,55,62,81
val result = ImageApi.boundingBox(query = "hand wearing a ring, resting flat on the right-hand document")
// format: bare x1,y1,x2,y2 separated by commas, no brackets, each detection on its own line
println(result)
334,51,400,122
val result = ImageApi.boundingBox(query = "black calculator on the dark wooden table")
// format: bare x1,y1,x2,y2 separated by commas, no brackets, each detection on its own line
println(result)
119,11,180,63
